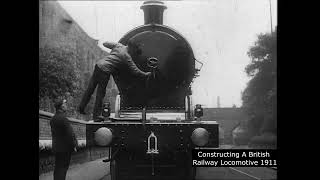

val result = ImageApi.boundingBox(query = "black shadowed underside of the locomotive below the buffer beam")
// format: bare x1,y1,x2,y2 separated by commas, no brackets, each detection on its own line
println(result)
110,151,195,180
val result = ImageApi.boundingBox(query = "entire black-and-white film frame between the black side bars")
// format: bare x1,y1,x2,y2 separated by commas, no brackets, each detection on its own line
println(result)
39,0,279,180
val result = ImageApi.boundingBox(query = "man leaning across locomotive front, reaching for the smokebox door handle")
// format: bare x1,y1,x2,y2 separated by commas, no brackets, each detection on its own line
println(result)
78,40,151,121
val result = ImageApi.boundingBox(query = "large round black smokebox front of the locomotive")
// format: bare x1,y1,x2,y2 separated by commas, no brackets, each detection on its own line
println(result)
114,24,196,110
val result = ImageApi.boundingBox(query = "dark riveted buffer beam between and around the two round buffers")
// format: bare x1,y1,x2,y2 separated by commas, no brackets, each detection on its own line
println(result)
86,122,219,149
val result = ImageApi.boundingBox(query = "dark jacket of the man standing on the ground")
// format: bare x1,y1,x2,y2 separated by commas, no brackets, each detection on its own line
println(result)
50,112,78,152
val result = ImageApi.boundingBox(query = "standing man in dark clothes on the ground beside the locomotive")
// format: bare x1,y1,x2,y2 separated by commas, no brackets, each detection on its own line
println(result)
50,98,78,180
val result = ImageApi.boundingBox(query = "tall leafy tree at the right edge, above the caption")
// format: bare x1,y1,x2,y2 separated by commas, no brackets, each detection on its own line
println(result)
242,29,277,134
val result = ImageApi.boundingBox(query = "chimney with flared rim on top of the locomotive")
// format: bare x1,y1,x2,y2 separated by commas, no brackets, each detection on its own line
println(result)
140,0,167,24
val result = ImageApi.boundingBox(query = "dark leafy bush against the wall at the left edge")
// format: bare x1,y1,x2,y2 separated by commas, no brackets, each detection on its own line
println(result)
39,47,77,99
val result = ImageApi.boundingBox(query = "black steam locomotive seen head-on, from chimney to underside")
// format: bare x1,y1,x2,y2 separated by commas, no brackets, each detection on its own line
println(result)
86,1,219,180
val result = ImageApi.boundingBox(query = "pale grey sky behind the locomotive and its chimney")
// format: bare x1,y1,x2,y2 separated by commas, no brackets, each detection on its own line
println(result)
59,0,277,108
